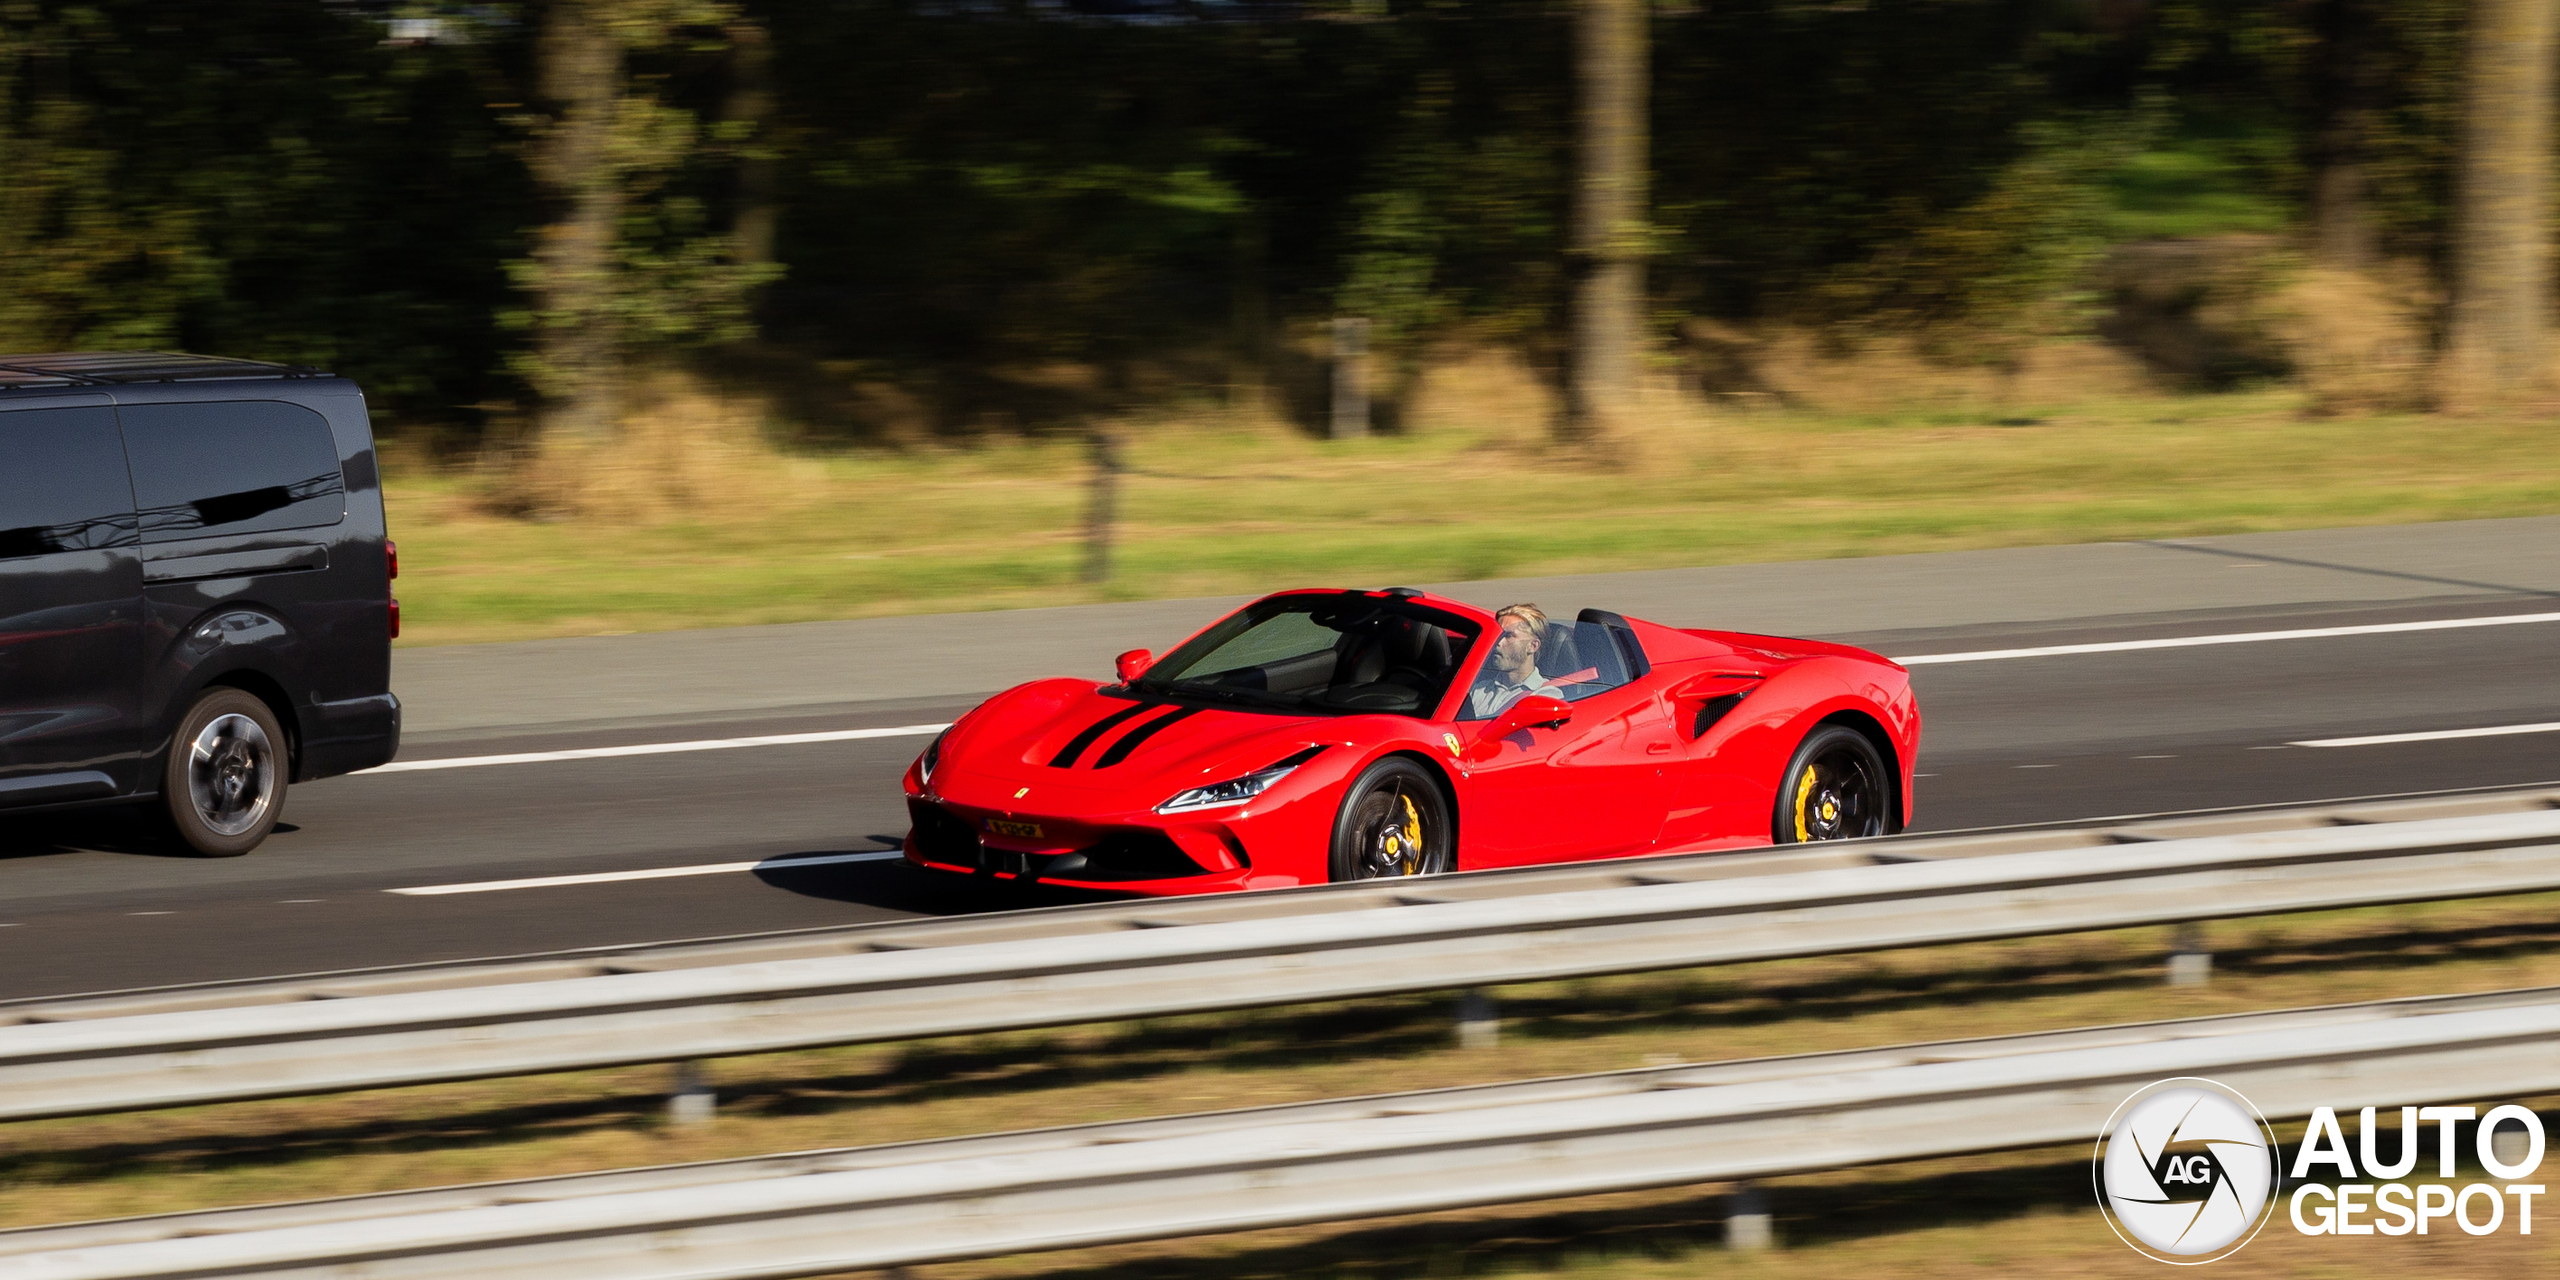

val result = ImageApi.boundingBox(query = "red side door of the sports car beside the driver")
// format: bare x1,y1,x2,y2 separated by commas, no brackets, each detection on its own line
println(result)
1459,681,1679,870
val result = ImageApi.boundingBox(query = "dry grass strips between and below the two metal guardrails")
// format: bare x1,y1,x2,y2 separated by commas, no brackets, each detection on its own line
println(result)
15,896,2560,1280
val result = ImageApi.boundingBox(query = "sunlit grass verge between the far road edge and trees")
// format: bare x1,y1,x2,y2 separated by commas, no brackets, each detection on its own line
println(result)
389,379,2560,645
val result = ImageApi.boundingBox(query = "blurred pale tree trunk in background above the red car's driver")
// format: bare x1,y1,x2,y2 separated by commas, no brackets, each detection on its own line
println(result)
1559,0,1651,445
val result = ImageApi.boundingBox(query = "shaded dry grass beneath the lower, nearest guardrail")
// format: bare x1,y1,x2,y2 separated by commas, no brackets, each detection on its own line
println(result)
847,1146,2560,1280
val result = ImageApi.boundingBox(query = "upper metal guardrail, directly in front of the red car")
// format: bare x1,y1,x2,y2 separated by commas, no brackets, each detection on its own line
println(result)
0,806,2560,1119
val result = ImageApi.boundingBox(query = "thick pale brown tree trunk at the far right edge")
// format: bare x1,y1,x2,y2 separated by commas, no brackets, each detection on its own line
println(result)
2445,0,2560,407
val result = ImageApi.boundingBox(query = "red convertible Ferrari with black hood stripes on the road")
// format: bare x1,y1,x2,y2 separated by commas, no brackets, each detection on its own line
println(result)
906,586,1920,893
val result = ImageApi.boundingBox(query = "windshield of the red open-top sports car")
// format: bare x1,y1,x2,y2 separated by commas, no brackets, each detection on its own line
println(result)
1132,591,1477,717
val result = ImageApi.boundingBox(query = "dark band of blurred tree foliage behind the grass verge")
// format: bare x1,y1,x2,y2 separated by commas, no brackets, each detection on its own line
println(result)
0,0,2508,440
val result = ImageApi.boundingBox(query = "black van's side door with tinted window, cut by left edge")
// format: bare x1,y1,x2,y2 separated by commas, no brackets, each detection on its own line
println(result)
0,397,154,806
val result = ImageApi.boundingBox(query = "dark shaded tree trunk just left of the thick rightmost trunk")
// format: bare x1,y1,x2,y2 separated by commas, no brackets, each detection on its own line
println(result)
2312,0,2383,271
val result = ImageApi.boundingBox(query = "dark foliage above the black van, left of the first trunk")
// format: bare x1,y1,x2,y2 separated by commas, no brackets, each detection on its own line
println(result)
0,0,527,412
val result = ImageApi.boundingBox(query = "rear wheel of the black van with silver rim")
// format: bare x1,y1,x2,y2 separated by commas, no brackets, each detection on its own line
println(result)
161,689,289,858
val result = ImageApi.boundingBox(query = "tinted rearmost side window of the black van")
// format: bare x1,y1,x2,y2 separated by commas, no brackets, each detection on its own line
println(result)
118,399,346,543
